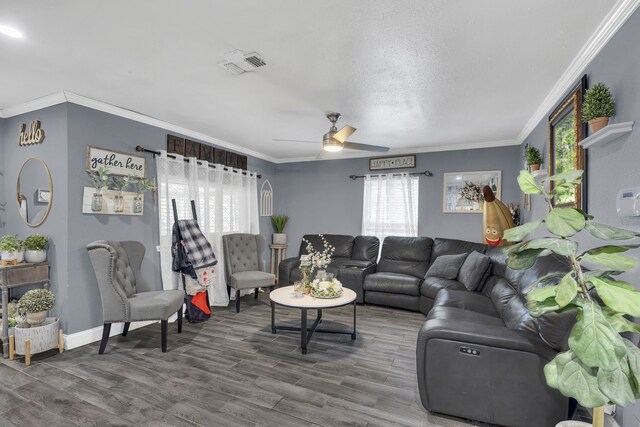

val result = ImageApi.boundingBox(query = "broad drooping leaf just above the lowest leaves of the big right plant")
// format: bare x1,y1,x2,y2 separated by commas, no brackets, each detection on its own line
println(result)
569,302,627,371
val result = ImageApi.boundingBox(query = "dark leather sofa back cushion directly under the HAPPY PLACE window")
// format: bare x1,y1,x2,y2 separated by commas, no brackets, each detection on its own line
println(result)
378,236,433,279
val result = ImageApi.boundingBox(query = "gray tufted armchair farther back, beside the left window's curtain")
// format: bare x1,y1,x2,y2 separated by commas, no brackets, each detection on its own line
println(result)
222,233,275,313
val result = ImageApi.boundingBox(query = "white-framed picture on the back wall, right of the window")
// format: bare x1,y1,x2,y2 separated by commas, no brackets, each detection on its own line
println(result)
442,171,502,213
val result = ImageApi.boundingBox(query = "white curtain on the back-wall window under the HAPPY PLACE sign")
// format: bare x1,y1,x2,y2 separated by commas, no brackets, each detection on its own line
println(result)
362,173,419,241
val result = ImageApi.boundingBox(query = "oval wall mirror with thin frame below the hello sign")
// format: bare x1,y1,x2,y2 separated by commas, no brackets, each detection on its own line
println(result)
16,157,53,227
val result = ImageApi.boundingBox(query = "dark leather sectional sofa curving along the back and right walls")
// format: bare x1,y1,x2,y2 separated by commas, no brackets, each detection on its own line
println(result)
280,236,574,427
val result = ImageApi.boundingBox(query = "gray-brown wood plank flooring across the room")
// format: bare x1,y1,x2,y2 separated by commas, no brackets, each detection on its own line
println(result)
0,293,484,427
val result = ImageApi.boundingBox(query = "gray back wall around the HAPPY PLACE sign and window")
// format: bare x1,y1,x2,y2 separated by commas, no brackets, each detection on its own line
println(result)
274,146,522,256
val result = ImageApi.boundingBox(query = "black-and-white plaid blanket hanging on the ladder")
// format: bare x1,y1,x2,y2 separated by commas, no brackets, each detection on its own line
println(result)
171,219,218,271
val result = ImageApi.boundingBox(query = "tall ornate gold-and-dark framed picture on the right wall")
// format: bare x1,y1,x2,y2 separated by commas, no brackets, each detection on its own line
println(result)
547,75,587,210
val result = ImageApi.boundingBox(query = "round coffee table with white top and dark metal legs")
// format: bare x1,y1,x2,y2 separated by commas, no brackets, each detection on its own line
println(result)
269,286,356,354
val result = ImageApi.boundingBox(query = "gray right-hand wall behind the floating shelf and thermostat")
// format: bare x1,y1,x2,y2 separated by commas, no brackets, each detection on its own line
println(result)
523,10,640,426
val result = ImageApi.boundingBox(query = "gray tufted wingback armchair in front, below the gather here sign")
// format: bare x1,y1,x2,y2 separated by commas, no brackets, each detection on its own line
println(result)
87,240,184,354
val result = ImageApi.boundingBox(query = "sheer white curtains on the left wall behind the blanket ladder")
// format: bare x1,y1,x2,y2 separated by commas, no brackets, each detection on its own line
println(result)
156,150,260,306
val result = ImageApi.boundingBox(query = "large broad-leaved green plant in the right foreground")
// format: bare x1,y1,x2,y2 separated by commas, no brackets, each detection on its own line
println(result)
504,171,640,408
